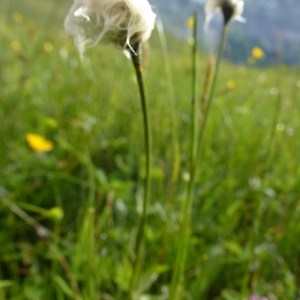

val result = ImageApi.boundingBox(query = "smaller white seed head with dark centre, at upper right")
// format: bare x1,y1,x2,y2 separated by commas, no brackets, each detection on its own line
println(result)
205,0,245,25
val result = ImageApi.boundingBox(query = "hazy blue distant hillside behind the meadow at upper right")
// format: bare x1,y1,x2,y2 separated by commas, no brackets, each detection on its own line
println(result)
150,0,300,64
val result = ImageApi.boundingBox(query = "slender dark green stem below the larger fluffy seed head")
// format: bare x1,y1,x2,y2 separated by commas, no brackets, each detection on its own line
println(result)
130,47,152,293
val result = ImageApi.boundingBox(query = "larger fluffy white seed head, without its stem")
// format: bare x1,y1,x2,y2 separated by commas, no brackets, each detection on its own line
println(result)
64,0,156,54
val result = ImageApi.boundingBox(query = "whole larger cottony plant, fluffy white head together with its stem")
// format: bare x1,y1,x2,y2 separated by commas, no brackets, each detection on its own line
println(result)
64,0,156,294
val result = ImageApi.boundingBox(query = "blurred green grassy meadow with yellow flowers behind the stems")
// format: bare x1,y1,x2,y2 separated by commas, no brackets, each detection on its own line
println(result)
0,0,300,300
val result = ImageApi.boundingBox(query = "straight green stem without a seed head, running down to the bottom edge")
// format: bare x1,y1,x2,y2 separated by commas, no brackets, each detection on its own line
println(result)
170,13,198,300
